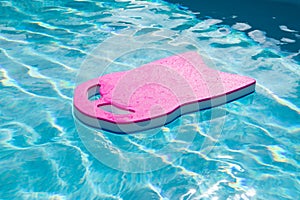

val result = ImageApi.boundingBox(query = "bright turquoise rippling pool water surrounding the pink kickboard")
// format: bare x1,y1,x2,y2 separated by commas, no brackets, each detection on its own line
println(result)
0,0,300,200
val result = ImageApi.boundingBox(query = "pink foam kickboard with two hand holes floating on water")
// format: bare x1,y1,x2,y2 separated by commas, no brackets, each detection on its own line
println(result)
73,52,255,133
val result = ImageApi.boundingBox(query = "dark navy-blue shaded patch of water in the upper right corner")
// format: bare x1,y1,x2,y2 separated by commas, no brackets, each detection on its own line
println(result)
168,0,300,61
